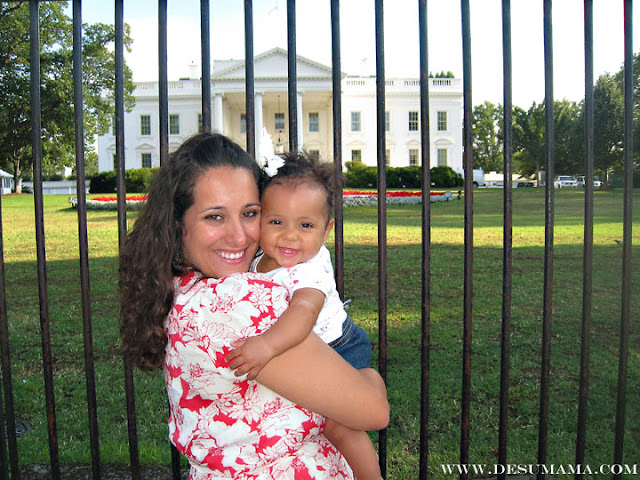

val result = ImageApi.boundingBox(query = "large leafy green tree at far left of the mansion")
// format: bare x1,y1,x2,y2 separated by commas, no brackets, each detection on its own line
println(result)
0,2,133,192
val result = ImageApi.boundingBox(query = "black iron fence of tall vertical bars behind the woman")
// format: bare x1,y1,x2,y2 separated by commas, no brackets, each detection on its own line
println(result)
0,0,637,479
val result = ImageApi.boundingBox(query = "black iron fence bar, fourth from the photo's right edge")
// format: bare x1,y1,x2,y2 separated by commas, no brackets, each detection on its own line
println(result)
498,0,513,480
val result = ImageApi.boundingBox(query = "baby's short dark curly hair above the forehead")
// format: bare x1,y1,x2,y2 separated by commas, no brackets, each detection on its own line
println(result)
260,151,335,218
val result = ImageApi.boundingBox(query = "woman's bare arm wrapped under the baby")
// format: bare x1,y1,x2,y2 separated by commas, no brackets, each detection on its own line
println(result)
256,333,389,430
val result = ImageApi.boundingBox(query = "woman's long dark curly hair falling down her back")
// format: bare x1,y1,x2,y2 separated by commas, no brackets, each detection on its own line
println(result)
120,133,260,370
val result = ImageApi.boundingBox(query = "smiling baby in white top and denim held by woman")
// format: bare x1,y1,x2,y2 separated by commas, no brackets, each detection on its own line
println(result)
227,153,381,480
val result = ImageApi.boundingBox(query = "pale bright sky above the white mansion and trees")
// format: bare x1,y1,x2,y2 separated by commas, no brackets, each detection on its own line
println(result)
68,0,640,109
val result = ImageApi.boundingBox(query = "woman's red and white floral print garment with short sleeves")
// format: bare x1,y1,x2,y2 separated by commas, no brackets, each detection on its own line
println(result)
164,273,353,480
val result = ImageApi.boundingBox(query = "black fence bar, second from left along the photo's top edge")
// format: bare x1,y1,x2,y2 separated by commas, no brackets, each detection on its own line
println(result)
73,0,101,480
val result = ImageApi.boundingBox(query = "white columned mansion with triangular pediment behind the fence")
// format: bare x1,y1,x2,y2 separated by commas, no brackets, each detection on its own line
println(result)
98,48,462,172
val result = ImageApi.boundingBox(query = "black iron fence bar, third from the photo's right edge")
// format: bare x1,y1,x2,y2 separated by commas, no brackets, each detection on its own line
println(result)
537,0,555,480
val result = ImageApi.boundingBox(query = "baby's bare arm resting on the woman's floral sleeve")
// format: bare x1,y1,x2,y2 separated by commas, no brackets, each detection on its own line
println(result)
227,288,325,380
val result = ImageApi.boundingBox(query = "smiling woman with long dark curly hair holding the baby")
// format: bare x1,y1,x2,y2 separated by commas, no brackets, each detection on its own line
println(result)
120,134,389,480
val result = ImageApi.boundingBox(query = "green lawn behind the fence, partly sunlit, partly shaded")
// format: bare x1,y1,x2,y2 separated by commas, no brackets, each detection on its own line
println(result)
2,189,640,479
